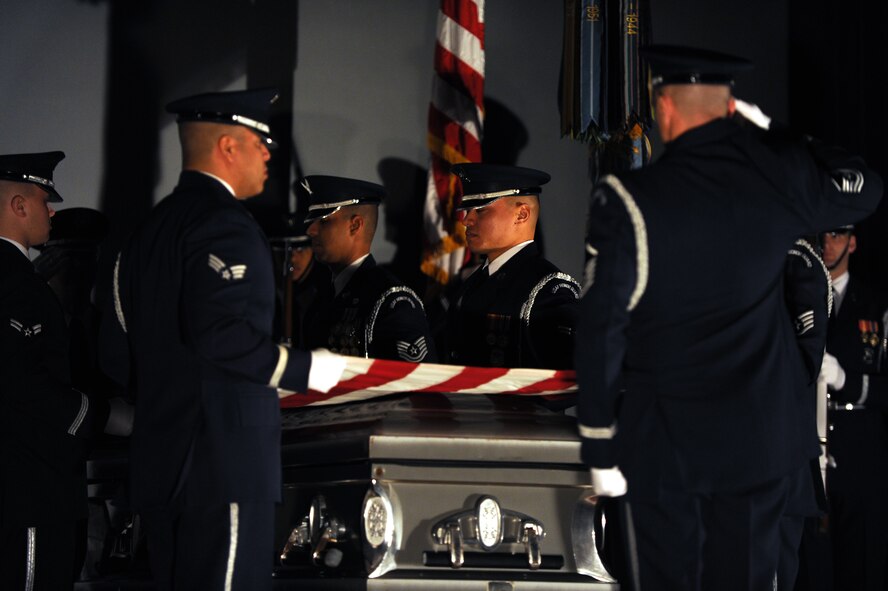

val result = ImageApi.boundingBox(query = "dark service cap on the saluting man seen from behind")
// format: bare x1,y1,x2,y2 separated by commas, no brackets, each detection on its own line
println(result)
641,45,752,88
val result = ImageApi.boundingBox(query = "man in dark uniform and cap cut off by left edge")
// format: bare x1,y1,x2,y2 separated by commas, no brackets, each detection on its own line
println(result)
0,152,123,590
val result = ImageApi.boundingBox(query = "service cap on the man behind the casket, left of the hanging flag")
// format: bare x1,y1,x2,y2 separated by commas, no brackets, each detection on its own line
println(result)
294,175,385,224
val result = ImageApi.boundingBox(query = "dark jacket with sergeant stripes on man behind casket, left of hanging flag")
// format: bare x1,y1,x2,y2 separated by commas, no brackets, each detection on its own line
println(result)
305,255,437,363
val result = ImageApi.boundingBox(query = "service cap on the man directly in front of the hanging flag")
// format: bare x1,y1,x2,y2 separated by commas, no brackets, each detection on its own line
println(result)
450,162,552,210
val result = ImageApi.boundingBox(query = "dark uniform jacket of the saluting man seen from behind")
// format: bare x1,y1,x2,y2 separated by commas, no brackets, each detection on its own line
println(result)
576,119,882,494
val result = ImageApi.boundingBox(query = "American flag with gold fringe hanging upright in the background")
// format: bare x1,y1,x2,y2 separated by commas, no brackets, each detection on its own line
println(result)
421,0,484,284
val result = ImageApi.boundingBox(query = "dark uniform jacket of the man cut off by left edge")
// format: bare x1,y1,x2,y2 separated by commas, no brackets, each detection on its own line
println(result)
0,240,108,527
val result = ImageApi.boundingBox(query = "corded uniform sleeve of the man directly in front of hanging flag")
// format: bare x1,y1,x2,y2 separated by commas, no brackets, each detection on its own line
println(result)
521,273,580,369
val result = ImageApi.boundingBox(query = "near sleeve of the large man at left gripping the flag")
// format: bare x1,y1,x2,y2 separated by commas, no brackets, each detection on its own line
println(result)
181,210,311,392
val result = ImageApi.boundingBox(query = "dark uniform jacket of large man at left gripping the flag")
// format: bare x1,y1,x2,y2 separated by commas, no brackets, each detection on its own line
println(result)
103,171,310,508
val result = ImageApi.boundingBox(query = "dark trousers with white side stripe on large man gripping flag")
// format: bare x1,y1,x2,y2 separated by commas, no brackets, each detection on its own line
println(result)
140,501,274,591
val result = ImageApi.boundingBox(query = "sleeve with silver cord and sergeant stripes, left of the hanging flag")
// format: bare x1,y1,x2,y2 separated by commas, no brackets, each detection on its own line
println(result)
365,286,438,363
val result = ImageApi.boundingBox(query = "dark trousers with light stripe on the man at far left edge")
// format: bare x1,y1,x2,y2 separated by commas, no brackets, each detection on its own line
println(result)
0,520,79,591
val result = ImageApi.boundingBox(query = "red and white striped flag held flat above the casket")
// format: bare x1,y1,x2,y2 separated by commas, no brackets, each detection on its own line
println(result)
281,357,577,408
